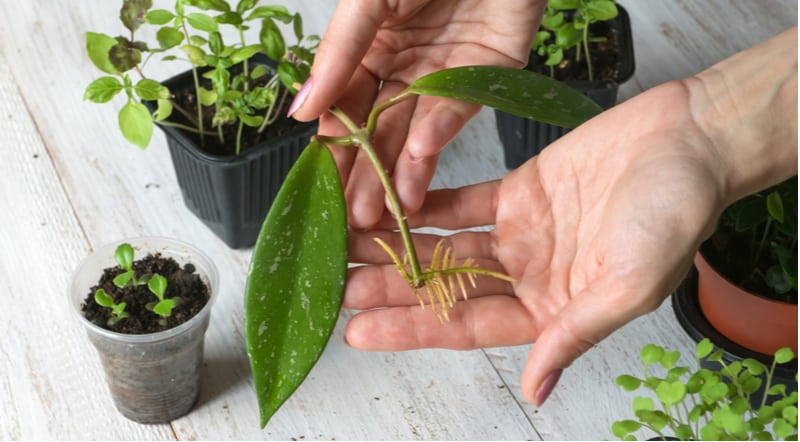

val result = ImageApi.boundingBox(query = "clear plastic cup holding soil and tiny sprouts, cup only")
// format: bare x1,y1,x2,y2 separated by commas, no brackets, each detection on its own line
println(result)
69,237,219,423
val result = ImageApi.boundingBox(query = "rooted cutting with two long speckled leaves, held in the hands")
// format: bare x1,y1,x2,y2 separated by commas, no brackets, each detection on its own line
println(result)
244,66,601,427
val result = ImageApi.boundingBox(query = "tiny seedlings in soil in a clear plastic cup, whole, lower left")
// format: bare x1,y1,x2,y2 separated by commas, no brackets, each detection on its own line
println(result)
69,237,219,423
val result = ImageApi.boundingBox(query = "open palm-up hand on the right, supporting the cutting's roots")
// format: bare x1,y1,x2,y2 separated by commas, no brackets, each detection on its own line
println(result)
344,82,724,405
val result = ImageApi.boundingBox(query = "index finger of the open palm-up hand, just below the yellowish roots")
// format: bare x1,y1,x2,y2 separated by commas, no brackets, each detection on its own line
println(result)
345,295,537,351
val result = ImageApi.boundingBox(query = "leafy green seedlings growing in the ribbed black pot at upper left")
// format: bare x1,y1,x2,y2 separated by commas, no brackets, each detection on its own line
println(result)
84,0,319,154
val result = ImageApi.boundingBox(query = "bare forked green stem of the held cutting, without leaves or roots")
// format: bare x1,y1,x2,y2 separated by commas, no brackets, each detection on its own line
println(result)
330,101,425,288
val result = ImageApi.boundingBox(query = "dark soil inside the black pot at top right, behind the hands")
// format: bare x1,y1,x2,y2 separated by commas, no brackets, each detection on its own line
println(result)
525,21,622,82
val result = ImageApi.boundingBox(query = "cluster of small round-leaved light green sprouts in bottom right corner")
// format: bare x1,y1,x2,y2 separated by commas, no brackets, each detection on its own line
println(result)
611,338,797,440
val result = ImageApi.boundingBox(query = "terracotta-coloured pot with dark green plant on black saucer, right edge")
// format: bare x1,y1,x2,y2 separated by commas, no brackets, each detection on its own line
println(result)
672,176,798,408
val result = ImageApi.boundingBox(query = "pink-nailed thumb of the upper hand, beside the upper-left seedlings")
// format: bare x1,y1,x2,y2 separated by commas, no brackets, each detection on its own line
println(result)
292,0,388,121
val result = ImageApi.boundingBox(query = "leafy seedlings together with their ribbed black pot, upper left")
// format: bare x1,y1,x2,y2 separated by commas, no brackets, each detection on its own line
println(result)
84,0,318,248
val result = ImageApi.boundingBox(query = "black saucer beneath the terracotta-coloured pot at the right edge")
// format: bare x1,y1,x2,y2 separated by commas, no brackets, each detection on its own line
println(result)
672,267,797,409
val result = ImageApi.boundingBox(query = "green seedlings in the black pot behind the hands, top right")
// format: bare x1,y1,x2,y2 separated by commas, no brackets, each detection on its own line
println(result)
531,0,618,81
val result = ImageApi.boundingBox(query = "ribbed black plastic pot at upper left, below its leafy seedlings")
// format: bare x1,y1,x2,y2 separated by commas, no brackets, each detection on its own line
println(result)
145,54,317,248
